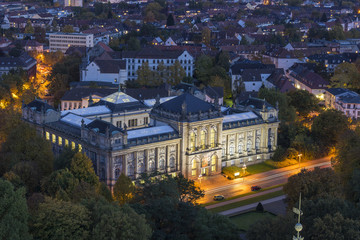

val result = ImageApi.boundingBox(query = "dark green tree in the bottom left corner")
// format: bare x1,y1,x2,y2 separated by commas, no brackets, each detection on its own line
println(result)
0,179,31,240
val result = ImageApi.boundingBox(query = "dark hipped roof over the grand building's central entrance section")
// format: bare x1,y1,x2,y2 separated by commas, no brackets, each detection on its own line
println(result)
158,93,216,114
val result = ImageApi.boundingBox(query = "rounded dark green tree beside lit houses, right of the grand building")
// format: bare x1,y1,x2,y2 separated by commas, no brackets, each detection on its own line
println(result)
287,90,319,117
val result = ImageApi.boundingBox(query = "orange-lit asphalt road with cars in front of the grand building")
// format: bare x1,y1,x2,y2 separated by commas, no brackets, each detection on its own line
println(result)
199,157,331,203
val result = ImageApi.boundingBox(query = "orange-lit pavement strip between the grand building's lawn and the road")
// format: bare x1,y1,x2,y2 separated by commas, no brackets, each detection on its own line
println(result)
195,157,330,192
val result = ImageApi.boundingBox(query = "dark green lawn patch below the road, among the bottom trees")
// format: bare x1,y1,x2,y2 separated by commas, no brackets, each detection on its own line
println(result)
230,211,276,232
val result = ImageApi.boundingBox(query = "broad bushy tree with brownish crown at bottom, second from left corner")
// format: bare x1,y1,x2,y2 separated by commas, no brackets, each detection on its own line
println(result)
30,198,90,240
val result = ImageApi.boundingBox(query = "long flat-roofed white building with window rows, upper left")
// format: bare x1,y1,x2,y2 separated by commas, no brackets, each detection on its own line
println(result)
49,33,94,53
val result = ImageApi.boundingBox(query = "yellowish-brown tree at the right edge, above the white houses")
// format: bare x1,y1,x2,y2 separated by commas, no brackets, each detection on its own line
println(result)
330,62,360,89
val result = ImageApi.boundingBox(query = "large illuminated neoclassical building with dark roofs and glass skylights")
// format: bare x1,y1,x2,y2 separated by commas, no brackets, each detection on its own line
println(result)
22,91,279,186
